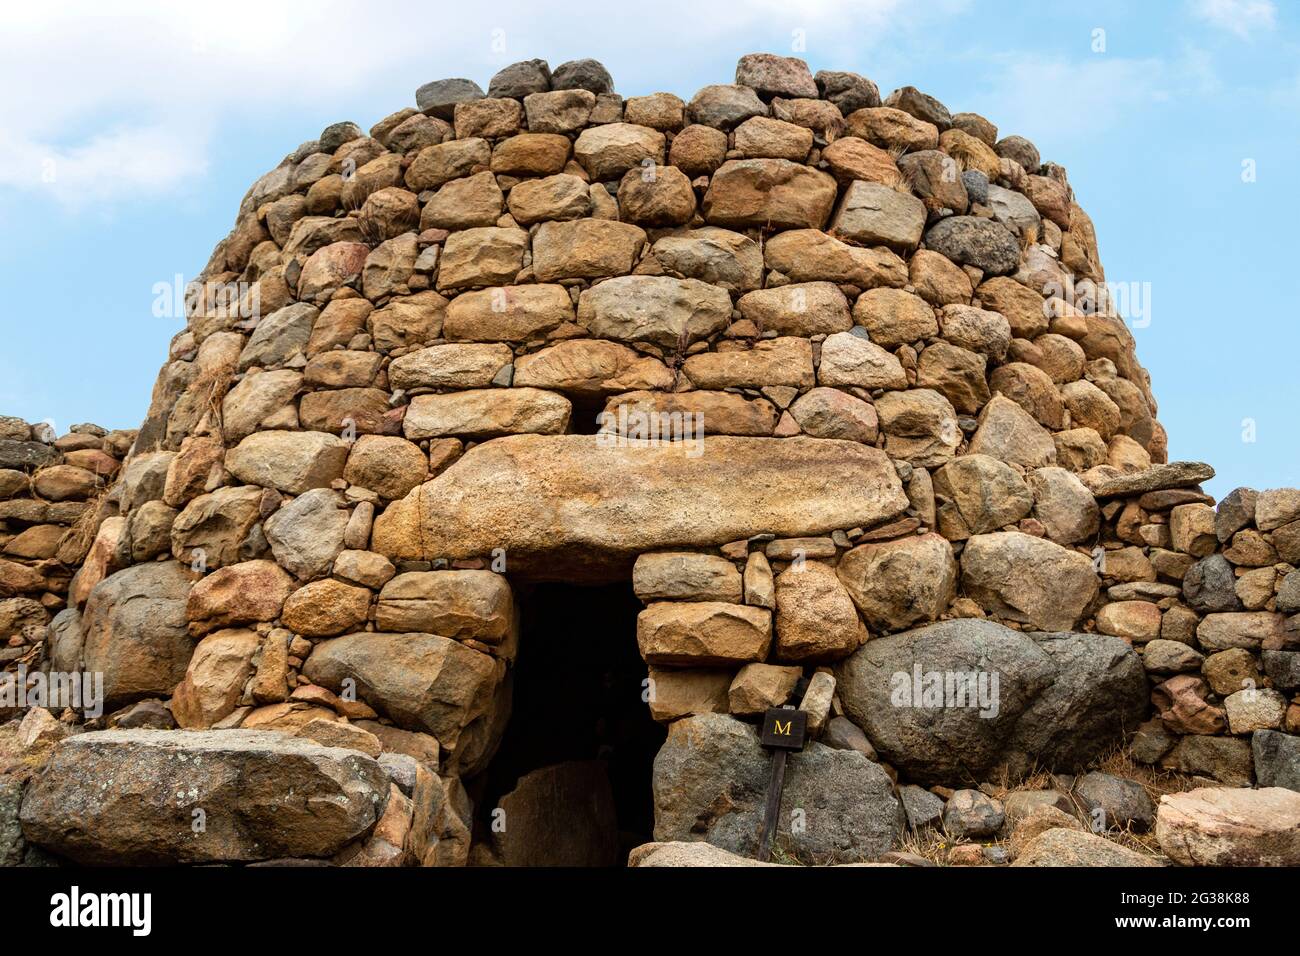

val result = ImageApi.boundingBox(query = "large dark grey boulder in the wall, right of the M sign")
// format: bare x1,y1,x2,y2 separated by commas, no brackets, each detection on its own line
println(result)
836,620,1147,786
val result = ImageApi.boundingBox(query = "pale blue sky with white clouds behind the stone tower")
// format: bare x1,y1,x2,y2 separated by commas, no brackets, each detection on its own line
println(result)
0,0,1300,496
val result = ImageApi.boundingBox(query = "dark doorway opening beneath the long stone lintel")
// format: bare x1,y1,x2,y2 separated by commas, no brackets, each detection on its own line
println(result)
475,581,667,865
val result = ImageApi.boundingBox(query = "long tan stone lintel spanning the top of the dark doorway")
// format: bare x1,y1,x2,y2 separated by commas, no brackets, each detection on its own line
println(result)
372,434,907,579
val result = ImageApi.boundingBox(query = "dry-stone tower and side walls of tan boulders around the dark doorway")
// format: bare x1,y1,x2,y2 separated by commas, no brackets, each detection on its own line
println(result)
0,55,1300,865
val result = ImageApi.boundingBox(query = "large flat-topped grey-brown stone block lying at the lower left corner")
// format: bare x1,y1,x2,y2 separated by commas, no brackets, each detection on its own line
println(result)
21,730,389,866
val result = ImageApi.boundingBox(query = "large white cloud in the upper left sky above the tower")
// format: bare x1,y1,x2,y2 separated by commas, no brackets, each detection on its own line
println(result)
0,0,935,203
